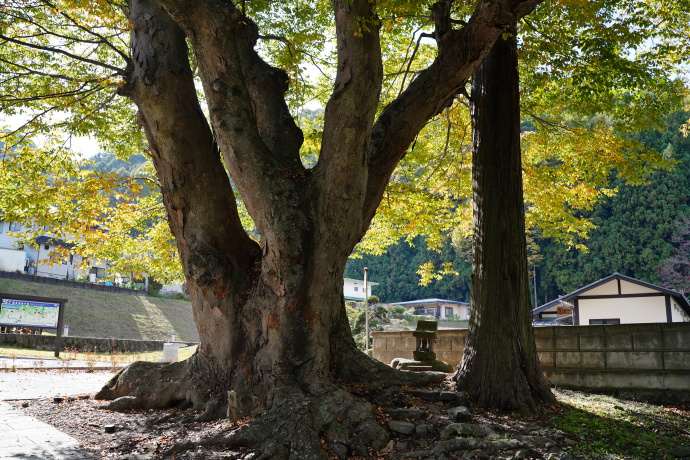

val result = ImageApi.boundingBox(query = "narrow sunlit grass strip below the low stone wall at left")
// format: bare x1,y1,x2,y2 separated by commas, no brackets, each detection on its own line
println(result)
0,345,197,364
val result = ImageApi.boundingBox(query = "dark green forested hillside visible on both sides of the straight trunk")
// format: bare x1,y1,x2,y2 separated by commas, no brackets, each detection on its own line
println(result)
346,112,690,304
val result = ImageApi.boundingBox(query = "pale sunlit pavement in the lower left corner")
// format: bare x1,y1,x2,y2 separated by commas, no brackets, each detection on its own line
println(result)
0,370,115,460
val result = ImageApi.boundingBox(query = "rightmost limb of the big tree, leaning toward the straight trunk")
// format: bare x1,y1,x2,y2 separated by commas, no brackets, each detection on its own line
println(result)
363,0,542,229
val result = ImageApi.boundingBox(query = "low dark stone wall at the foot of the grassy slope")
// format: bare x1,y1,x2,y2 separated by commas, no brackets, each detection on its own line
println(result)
0,334,172,352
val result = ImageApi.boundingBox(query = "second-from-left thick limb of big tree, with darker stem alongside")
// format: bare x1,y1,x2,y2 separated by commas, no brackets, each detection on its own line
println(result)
161,0,306,235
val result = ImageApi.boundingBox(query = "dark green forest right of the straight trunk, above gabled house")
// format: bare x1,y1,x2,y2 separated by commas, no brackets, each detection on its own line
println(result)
537,112,690,299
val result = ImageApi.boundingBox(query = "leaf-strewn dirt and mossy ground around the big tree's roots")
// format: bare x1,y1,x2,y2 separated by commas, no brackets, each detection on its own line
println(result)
6,370,690,460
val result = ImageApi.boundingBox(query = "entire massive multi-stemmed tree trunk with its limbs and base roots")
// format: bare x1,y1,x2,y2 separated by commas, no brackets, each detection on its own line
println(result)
98,0,540,458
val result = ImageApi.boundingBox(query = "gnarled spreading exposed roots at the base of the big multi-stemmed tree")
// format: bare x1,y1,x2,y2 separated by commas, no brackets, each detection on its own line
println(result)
96,318,444,460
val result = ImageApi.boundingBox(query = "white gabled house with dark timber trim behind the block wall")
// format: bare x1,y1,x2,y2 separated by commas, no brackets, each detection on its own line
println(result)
532,273,690,326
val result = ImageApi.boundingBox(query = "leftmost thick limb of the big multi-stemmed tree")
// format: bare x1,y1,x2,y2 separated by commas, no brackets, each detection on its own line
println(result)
121,0,259,280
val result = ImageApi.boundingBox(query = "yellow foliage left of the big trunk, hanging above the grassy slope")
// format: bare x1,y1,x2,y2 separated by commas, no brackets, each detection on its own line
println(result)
0,131,181,282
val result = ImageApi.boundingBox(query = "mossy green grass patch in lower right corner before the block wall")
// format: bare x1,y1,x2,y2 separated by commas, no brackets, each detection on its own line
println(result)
551,390,690,460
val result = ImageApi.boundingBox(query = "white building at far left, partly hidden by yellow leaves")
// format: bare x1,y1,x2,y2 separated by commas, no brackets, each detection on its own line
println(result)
0,221,109,281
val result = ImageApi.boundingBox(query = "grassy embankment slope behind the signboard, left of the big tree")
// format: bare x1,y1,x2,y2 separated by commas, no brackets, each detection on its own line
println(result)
0,279,199,342
